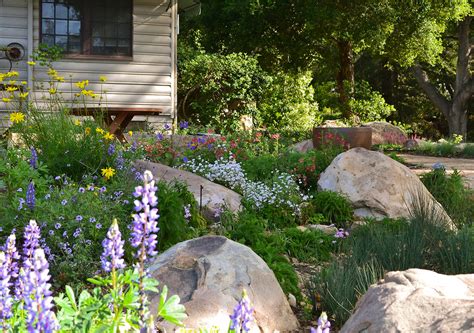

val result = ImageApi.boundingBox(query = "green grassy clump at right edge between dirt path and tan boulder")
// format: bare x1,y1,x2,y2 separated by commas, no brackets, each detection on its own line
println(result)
421,168,474,227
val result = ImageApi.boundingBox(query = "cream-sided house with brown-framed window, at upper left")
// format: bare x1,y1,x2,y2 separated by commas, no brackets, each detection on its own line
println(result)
0,0,199,131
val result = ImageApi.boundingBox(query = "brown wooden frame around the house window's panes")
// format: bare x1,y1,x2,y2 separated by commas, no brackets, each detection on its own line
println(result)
37,0,135,60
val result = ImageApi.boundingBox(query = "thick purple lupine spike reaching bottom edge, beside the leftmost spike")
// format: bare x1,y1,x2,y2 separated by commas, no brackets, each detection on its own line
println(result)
24,248,59,332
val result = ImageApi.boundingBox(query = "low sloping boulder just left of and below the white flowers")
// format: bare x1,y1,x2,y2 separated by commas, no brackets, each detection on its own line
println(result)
135,160,242,218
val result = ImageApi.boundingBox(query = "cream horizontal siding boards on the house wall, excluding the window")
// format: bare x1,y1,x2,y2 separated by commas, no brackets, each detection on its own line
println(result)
0,0,176,130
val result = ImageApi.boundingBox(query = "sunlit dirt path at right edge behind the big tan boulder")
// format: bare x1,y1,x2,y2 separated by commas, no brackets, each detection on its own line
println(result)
398,154,474,189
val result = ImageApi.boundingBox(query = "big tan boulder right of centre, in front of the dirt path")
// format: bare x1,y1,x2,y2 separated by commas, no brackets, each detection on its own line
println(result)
318,148,454,228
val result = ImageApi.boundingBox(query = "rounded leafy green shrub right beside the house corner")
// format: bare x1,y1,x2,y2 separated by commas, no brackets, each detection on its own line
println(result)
178,44,269,130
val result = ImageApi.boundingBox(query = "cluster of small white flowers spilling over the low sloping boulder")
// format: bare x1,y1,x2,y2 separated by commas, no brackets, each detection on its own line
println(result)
182,157,308,213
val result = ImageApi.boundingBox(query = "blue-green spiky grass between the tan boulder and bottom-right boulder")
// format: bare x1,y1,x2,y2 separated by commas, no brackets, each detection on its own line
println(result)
313,211,474,324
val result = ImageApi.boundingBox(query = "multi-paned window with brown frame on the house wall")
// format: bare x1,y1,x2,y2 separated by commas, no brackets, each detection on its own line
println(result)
41,0,132,56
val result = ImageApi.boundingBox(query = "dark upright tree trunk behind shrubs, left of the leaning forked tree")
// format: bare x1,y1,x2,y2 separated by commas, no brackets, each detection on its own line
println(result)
336,40,354,118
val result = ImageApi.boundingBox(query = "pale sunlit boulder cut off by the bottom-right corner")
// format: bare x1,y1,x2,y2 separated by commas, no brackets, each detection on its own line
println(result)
341,269,474,333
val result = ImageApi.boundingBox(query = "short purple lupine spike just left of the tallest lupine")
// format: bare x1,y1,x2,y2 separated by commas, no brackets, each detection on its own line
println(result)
100,219,125,272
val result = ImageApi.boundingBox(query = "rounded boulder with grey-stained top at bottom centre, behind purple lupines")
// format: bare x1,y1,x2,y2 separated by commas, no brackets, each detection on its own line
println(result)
149,236,299,332
